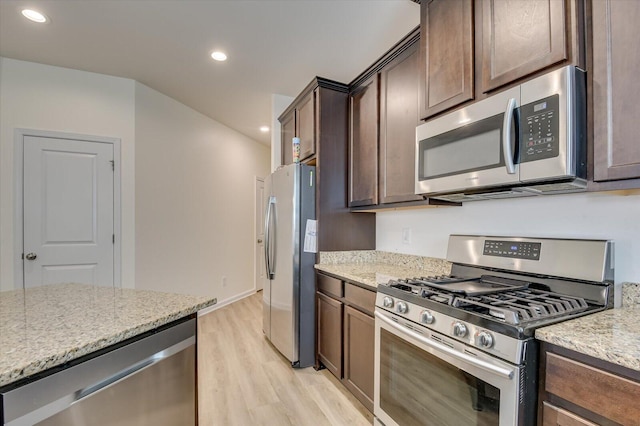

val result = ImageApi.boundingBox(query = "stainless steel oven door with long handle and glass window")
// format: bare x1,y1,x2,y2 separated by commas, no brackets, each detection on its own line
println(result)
374,308,535,426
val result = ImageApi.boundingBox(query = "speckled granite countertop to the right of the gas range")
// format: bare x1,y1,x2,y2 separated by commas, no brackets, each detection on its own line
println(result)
536,283,640,371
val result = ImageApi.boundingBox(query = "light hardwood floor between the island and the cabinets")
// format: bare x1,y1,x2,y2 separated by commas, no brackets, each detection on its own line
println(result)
198,292,373,426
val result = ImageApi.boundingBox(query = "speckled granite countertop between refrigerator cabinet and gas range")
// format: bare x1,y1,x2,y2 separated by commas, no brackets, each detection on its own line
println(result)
315,250,451,290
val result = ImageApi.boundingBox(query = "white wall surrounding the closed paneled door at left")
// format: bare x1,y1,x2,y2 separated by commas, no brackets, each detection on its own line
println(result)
0,58,135,290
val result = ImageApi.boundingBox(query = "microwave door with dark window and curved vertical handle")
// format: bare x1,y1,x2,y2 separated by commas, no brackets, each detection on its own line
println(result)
416,87,520,194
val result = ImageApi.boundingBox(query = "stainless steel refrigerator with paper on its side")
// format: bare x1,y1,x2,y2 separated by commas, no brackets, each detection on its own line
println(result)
262,164,317,367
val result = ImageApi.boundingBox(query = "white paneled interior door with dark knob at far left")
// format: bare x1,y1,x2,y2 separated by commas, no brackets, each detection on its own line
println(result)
23,135,115,287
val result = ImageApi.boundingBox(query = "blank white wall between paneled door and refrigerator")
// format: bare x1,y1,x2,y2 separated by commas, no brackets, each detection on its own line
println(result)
135,83,270,303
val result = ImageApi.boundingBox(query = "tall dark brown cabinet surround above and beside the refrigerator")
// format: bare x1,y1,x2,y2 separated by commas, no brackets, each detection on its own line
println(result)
278,77,376,251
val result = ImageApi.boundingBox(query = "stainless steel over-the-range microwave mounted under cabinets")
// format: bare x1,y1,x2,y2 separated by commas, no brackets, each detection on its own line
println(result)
415,66,586,201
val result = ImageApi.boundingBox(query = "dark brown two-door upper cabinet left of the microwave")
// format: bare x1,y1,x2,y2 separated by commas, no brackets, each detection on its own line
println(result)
349,28,455,211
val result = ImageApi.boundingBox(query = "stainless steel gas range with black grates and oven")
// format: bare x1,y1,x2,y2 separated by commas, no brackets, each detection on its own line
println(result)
374,235,613,426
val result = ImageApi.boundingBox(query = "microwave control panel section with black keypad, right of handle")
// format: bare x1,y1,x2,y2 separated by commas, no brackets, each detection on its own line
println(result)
520,66,586,183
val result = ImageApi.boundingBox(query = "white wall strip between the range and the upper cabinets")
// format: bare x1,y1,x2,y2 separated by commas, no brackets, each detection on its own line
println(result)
376,191,640,300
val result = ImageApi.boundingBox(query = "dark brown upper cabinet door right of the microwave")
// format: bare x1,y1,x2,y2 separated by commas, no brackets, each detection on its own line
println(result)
592,0,640,181
